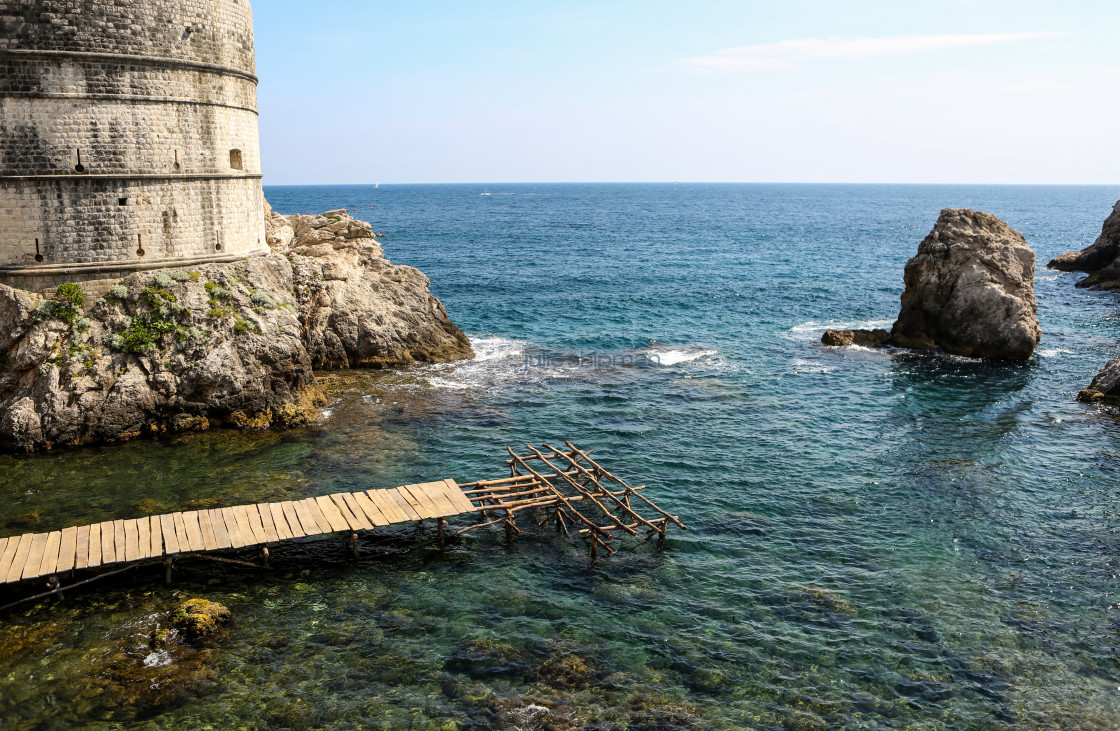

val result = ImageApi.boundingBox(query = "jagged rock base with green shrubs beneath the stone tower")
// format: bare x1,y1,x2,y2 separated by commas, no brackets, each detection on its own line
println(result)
0,204,472,451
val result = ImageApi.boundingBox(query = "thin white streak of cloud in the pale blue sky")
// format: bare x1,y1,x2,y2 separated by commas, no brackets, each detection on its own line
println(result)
682,32,1062,72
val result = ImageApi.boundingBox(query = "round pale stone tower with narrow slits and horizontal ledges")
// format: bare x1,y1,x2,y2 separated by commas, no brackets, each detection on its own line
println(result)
0,0,268,290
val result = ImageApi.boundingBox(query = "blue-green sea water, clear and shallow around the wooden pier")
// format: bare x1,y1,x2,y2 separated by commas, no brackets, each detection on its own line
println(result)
0,185,1120,729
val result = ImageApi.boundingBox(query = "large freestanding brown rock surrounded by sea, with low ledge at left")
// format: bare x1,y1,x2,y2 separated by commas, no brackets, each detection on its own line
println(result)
822,208,1042,360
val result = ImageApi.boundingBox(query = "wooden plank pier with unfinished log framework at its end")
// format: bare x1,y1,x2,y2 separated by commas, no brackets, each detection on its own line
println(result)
0,442,684,593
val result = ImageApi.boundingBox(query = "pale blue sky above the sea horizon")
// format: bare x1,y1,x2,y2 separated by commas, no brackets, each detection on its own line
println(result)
253,0,1120,185
